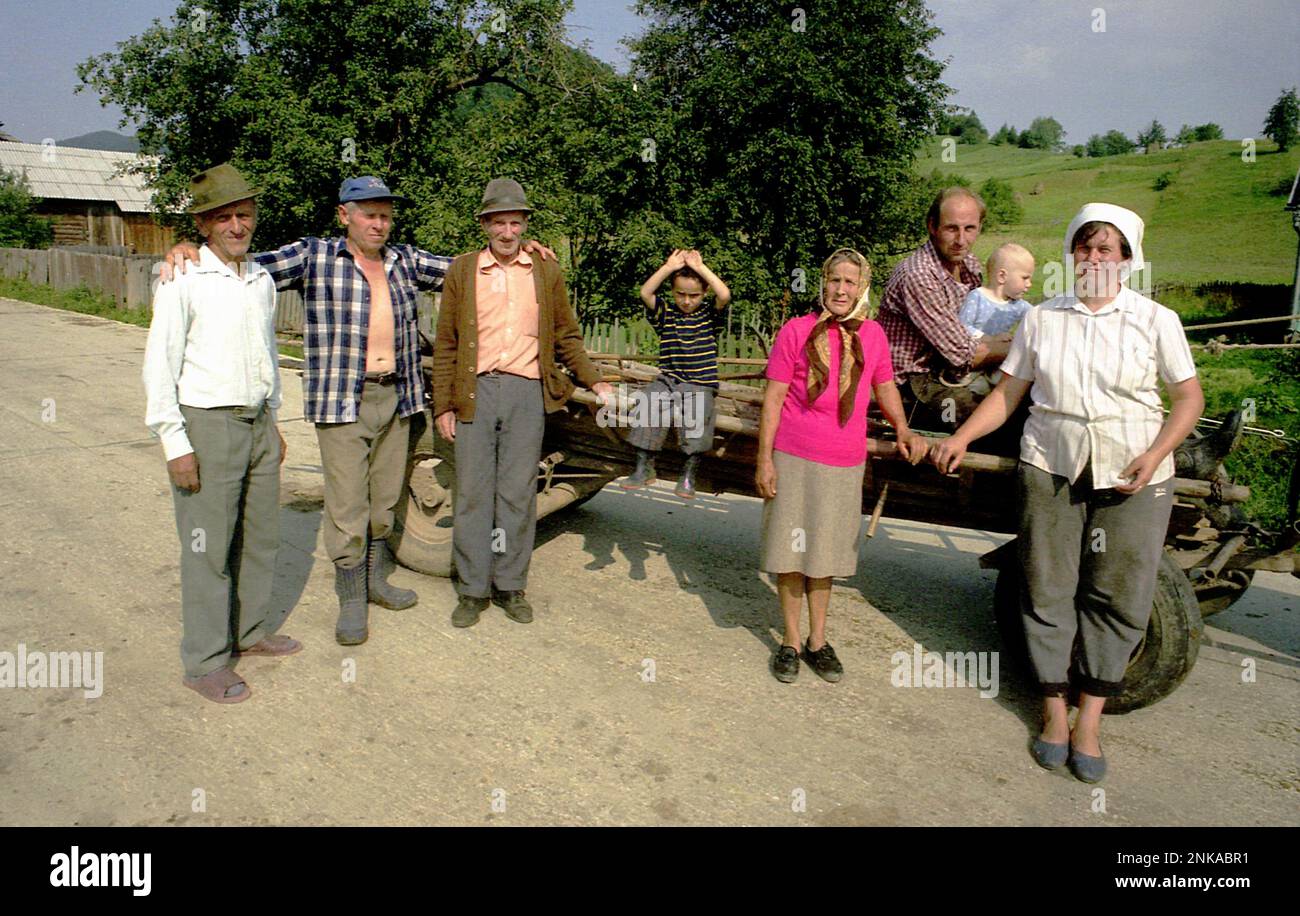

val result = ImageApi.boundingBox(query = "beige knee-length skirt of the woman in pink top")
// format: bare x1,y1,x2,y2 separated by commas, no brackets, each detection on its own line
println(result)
758,451,866,578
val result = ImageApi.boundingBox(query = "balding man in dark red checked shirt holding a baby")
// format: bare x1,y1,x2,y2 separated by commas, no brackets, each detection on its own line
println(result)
878,187,1011,430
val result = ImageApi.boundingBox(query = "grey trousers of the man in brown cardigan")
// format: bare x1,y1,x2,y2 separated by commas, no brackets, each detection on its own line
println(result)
451,373,546,598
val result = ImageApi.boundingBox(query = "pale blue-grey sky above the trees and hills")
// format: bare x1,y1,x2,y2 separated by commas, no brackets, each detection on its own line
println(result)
0,0,1300,143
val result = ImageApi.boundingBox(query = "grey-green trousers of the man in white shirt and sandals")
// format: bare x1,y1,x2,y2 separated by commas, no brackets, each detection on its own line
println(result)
172,407,287,677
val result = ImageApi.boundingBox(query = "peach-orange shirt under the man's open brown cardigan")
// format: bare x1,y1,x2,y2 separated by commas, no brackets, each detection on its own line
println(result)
475,248,542,378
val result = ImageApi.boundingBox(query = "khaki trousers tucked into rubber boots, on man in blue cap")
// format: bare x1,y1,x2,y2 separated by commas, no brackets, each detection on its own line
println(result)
316,379,411,569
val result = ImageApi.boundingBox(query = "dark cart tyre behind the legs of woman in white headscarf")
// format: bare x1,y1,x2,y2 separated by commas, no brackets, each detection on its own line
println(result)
993,545,1204,713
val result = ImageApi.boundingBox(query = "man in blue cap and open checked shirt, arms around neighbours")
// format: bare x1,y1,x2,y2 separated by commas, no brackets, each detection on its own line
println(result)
169,175,555,646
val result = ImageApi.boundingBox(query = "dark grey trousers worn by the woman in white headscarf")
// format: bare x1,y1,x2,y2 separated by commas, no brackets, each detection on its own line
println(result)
1019,461,1174,696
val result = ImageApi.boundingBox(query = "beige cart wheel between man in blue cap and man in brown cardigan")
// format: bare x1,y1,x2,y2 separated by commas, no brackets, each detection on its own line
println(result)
389,424,456,577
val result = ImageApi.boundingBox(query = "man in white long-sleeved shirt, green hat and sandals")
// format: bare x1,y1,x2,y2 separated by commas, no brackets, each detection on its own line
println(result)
143,164,302,703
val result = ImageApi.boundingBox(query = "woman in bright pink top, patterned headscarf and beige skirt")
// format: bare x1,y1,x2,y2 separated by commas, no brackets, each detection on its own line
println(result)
754,248,927,683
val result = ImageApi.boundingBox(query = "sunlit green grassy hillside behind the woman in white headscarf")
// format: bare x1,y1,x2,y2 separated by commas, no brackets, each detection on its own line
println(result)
917,140,1300,286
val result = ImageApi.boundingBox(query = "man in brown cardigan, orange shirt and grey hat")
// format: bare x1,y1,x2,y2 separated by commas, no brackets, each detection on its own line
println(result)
433,178,614,626
